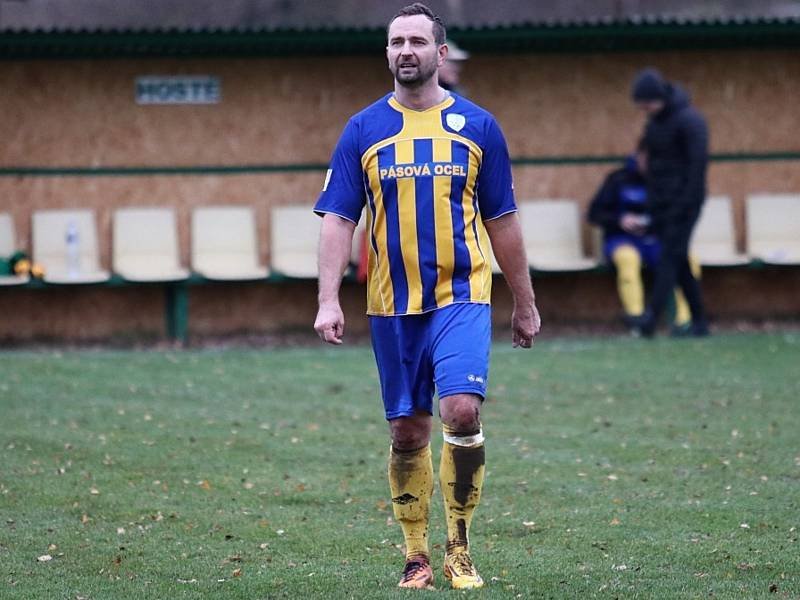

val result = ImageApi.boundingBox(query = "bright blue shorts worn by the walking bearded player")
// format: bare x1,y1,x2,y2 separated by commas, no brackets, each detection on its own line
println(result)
369,303,492,420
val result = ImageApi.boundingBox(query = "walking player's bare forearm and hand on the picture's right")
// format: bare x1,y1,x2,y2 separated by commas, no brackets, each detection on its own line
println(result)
484,212,542,348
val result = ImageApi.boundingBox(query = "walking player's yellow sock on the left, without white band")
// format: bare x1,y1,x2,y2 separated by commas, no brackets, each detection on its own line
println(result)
389,444,433,558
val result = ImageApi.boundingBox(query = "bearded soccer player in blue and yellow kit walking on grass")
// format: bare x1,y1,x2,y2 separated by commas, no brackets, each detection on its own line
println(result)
314,3,540,589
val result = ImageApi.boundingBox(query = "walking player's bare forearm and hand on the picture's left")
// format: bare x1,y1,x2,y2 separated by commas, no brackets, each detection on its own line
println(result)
314,213,355,344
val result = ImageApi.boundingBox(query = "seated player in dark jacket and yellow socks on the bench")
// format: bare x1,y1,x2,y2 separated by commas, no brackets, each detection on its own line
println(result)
588,140,699,335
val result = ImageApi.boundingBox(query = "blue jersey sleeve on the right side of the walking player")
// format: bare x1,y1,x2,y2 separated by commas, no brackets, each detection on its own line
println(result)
478,119,517,221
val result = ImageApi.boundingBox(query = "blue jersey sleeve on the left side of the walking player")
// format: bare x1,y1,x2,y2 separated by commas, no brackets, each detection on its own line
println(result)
314,119,366,223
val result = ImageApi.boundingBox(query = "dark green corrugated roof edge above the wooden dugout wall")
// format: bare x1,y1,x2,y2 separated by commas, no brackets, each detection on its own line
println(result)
0,19,800,60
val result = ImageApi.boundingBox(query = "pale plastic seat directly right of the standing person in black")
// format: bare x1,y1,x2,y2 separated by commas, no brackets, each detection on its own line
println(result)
691,196,750,267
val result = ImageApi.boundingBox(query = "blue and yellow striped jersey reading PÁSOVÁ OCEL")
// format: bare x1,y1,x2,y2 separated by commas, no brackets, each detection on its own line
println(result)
314,94,516,316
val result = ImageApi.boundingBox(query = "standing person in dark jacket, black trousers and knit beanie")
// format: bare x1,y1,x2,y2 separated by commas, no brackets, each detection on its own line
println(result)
631,68,708,337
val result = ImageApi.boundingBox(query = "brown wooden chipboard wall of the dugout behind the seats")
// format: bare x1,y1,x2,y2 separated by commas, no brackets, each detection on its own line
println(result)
0,50,800,339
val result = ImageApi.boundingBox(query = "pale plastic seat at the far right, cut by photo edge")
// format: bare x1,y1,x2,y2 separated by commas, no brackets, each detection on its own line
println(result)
747,194,800,265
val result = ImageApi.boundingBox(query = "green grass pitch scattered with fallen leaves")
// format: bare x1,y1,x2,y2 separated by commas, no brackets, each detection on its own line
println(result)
0,333,800,600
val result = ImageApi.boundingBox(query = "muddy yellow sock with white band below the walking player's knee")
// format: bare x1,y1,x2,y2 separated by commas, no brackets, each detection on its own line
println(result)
439,425,486,552
